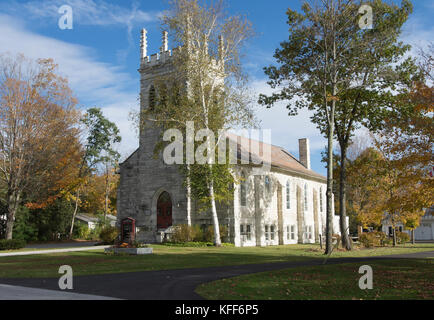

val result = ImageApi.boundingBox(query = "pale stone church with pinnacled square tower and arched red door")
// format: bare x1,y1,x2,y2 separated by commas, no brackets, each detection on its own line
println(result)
117,29,339,246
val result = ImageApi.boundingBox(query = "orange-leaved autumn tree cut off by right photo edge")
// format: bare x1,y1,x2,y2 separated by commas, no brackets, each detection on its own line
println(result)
375,46,434,243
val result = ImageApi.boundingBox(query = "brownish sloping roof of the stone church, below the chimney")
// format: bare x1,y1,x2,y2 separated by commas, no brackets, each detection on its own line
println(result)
228,133,327,181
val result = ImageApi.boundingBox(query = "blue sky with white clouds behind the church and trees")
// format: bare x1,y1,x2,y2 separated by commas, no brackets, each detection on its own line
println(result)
0,0,434,175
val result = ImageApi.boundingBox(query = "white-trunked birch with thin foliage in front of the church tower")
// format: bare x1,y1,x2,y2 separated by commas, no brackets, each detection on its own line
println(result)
143,0,254,246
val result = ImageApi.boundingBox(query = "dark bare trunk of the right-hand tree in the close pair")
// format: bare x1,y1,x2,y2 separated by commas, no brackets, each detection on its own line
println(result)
339,145,352,250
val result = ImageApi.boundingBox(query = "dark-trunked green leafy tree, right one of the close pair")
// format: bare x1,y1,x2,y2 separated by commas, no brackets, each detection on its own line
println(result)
330,1,417,249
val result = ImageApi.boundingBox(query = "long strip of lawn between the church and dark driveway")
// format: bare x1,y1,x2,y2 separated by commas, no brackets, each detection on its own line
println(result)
0,244,434,278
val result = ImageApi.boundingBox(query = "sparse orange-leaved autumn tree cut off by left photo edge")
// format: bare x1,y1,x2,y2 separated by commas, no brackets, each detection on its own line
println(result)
0,54,81,239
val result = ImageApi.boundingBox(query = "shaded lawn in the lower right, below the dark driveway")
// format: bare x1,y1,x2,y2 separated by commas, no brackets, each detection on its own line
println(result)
196,259,434,300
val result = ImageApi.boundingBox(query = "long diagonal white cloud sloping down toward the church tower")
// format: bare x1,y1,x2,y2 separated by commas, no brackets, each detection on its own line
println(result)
0,15,139,158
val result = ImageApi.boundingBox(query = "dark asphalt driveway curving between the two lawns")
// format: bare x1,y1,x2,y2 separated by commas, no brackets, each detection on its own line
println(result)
0,251,434,300
